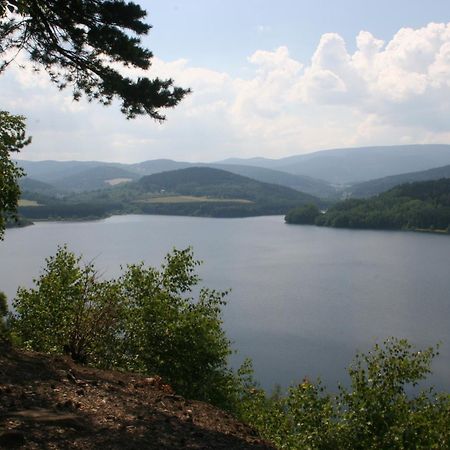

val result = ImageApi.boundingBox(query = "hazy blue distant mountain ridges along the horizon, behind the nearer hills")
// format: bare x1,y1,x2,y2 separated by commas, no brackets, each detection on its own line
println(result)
15,144,450,199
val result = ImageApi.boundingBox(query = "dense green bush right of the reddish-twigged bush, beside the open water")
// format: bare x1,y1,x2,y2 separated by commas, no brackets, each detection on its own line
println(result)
119,248,236,404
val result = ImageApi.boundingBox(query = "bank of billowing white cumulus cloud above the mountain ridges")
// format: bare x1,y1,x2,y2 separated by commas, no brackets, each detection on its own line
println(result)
0,23,450,161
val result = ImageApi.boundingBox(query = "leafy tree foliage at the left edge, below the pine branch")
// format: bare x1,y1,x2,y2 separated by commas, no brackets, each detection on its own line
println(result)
0,111,31,240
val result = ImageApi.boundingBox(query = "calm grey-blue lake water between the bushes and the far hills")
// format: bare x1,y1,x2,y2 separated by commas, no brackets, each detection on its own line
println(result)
0,216,450,389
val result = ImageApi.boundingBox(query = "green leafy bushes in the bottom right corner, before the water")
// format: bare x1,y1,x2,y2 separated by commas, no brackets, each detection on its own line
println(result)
241,339,450,450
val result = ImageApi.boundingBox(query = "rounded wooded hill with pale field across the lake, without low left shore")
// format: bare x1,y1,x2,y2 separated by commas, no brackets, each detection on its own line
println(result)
132,167,320,217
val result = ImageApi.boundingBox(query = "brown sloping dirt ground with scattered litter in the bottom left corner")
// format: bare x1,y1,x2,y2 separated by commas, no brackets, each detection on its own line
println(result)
0,345,273,450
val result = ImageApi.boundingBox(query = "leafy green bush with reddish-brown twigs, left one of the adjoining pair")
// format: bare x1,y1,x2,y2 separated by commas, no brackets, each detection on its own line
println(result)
11,247,121,366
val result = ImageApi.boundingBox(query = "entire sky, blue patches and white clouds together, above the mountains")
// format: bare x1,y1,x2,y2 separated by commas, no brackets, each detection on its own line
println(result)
0,0,450,163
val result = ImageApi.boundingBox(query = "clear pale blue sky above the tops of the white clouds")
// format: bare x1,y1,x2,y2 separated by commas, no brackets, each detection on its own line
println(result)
146,0,450,74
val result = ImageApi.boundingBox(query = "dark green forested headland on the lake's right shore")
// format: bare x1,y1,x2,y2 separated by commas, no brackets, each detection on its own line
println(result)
290,178,450,232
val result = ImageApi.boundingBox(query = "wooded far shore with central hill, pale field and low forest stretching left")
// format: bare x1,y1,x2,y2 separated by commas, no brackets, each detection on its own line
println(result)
20,167,323,219
